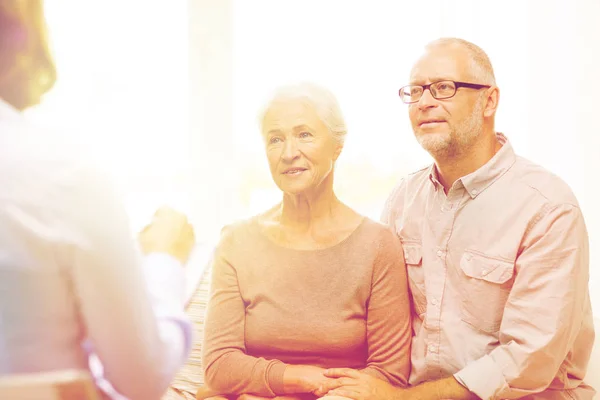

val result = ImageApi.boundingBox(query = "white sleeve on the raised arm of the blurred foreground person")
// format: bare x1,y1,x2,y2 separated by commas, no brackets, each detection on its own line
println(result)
65,168,191,399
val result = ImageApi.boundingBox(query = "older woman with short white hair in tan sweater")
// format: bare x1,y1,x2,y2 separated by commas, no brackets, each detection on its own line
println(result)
190,84,411,399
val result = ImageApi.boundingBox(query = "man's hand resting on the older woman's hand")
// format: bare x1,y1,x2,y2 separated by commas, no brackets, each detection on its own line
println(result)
317,368,406,400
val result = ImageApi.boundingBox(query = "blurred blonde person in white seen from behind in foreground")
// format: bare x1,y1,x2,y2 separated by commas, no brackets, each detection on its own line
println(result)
0,0,194,400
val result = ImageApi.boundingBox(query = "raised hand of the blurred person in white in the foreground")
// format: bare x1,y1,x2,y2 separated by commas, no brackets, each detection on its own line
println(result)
138,207,196,264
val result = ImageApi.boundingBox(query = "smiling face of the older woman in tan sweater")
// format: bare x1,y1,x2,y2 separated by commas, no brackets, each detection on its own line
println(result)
262,99,341,194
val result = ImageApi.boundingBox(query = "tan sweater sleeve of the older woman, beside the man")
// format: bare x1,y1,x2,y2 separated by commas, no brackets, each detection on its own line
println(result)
356,230,412,386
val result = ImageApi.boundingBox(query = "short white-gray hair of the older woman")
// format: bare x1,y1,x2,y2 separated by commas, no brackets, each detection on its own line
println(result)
259,82,348,145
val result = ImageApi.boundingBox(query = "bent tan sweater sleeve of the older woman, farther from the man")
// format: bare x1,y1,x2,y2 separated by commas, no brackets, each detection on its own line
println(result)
202,230,286,397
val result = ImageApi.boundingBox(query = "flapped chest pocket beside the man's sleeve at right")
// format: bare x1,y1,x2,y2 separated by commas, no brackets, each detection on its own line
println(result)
460,250,515,334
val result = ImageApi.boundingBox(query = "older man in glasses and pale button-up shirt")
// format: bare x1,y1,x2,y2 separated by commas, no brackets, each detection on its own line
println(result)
323,39,594,399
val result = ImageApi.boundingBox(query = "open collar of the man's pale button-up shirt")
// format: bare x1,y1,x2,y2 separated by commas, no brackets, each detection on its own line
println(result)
429,132,517,199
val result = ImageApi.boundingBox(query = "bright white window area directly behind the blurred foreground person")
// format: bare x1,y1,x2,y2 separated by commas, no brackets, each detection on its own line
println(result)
29,0,189,233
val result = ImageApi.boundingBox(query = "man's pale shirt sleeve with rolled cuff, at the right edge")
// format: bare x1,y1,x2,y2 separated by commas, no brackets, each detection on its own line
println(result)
455,204,589,399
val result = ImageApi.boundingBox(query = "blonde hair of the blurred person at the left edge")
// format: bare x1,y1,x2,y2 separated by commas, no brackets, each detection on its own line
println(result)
0,0,56,110
